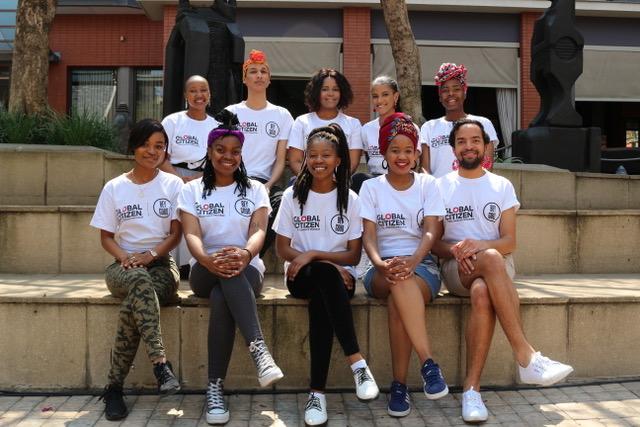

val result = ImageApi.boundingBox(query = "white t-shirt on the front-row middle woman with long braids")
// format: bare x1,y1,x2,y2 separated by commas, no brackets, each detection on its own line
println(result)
273,187,362,277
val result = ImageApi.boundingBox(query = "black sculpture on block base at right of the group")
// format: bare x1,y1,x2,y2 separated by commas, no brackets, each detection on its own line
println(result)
512,0,600,172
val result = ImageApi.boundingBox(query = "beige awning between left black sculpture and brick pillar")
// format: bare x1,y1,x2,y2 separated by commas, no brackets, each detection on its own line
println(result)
245,37,342,79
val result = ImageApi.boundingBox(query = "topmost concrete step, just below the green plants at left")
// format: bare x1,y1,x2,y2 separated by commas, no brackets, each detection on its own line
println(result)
0,144,640,210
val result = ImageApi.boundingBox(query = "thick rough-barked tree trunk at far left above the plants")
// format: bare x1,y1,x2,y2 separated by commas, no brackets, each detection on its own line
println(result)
9,0,56,114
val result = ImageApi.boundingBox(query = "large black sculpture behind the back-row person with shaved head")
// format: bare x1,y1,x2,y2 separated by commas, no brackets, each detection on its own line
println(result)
163,0,244,116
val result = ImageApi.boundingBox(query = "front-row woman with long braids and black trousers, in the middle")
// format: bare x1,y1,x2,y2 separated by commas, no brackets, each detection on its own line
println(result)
273,124,378,425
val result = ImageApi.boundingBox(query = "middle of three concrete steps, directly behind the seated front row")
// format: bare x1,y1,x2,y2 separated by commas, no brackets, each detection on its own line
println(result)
0,206,640,274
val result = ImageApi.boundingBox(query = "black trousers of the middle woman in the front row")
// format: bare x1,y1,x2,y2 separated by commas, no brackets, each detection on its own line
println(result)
287,261,360,390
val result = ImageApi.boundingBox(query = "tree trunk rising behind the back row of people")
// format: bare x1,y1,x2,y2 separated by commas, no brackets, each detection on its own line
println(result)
380,0,424,125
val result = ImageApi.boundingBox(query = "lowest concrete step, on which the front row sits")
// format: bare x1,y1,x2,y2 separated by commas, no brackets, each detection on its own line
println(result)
0,274,640,391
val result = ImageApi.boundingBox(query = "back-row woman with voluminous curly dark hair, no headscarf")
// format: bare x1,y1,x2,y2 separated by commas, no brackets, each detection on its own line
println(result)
287,68,362,175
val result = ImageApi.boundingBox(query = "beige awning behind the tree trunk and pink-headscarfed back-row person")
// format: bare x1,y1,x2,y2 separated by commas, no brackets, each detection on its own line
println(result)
373,41,519,88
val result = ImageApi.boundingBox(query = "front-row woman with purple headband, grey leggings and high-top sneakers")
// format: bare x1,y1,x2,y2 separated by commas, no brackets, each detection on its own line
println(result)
178,110,283,424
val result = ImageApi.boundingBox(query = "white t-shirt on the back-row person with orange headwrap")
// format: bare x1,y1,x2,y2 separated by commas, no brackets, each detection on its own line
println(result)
227,101,293,181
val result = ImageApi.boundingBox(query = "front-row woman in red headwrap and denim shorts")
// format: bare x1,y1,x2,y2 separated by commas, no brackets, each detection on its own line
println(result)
360,113,449,417
